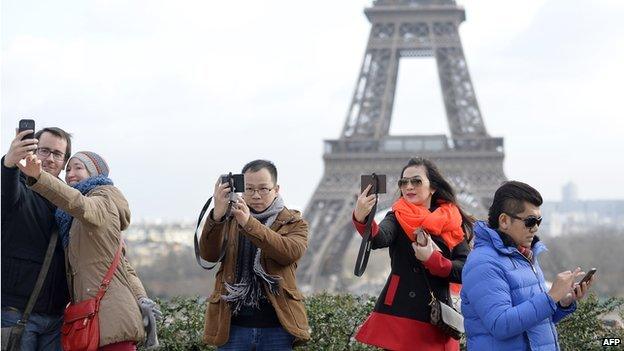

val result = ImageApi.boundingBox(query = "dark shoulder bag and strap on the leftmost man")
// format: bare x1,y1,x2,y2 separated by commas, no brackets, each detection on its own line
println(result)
0,229,58,351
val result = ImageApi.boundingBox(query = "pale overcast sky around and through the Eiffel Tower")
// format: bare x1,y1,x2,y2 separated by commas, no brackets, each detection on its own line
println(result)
1,0,624,220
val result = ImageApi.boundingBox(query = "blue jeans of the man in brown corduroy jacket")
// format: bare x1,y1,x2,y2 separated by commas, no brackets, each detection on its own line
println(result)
217,325,295,351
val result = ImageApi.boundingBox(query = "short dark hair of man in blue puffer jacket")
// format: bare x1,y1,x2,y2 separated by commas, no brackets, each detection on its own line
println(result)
488,180,544,229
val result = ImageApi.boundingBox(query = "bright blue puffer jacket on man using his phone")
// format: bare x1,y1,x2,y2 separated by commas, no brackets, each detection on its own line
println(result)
461,222,576,351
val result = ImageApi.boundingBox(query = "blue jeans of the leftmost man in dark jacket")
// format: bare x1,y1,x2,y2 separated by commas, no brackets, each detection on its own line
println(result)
2,307,63,351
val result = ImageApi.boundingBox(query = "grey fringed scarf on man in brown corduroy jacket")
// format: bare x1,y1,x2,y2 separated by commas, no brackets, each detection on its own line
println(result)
221,195,284,315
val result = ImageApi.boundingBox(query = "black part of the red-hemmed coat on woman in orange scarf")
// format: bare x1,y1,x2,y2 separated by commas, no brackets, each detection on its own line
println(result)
372,212,470,323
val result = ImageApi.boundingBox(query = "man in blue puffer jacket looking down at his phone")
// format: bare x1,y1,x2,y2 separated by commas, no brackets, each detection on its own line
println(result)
461,181,591,351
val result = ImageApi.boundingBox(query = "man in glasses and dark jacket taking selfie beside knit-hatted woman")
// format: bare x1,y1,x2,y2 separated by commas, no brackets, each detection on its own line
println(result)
1,128,71,351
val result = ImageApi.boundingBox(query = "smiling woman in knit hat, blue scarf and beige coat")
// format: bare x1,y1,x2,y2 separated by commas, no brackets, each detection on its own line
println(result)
18,151,160,351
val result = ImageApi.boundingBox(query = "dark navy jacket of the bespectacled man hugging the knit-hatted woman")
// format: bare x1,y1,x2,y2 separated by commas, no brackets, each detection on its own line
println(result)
1,157,69,314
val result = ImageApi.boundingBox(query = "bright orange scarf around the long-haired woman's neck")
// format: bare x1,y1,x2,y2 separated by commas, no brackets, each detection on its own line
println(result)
392,197,464,250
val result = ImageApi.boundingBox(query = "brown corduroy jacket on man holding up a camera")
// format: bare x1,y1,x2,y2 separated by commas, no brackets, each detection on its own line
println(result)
199,208,310,346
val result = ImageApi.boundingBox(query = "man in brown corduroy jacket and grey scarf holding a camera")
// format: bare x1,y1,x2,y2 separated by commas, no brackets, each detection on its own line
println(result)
200,160,310,350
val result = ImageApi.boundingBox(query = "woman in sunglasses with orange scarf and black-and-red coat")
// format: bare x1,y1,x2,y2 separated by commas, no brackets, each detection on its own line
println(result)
353,158,472,351
